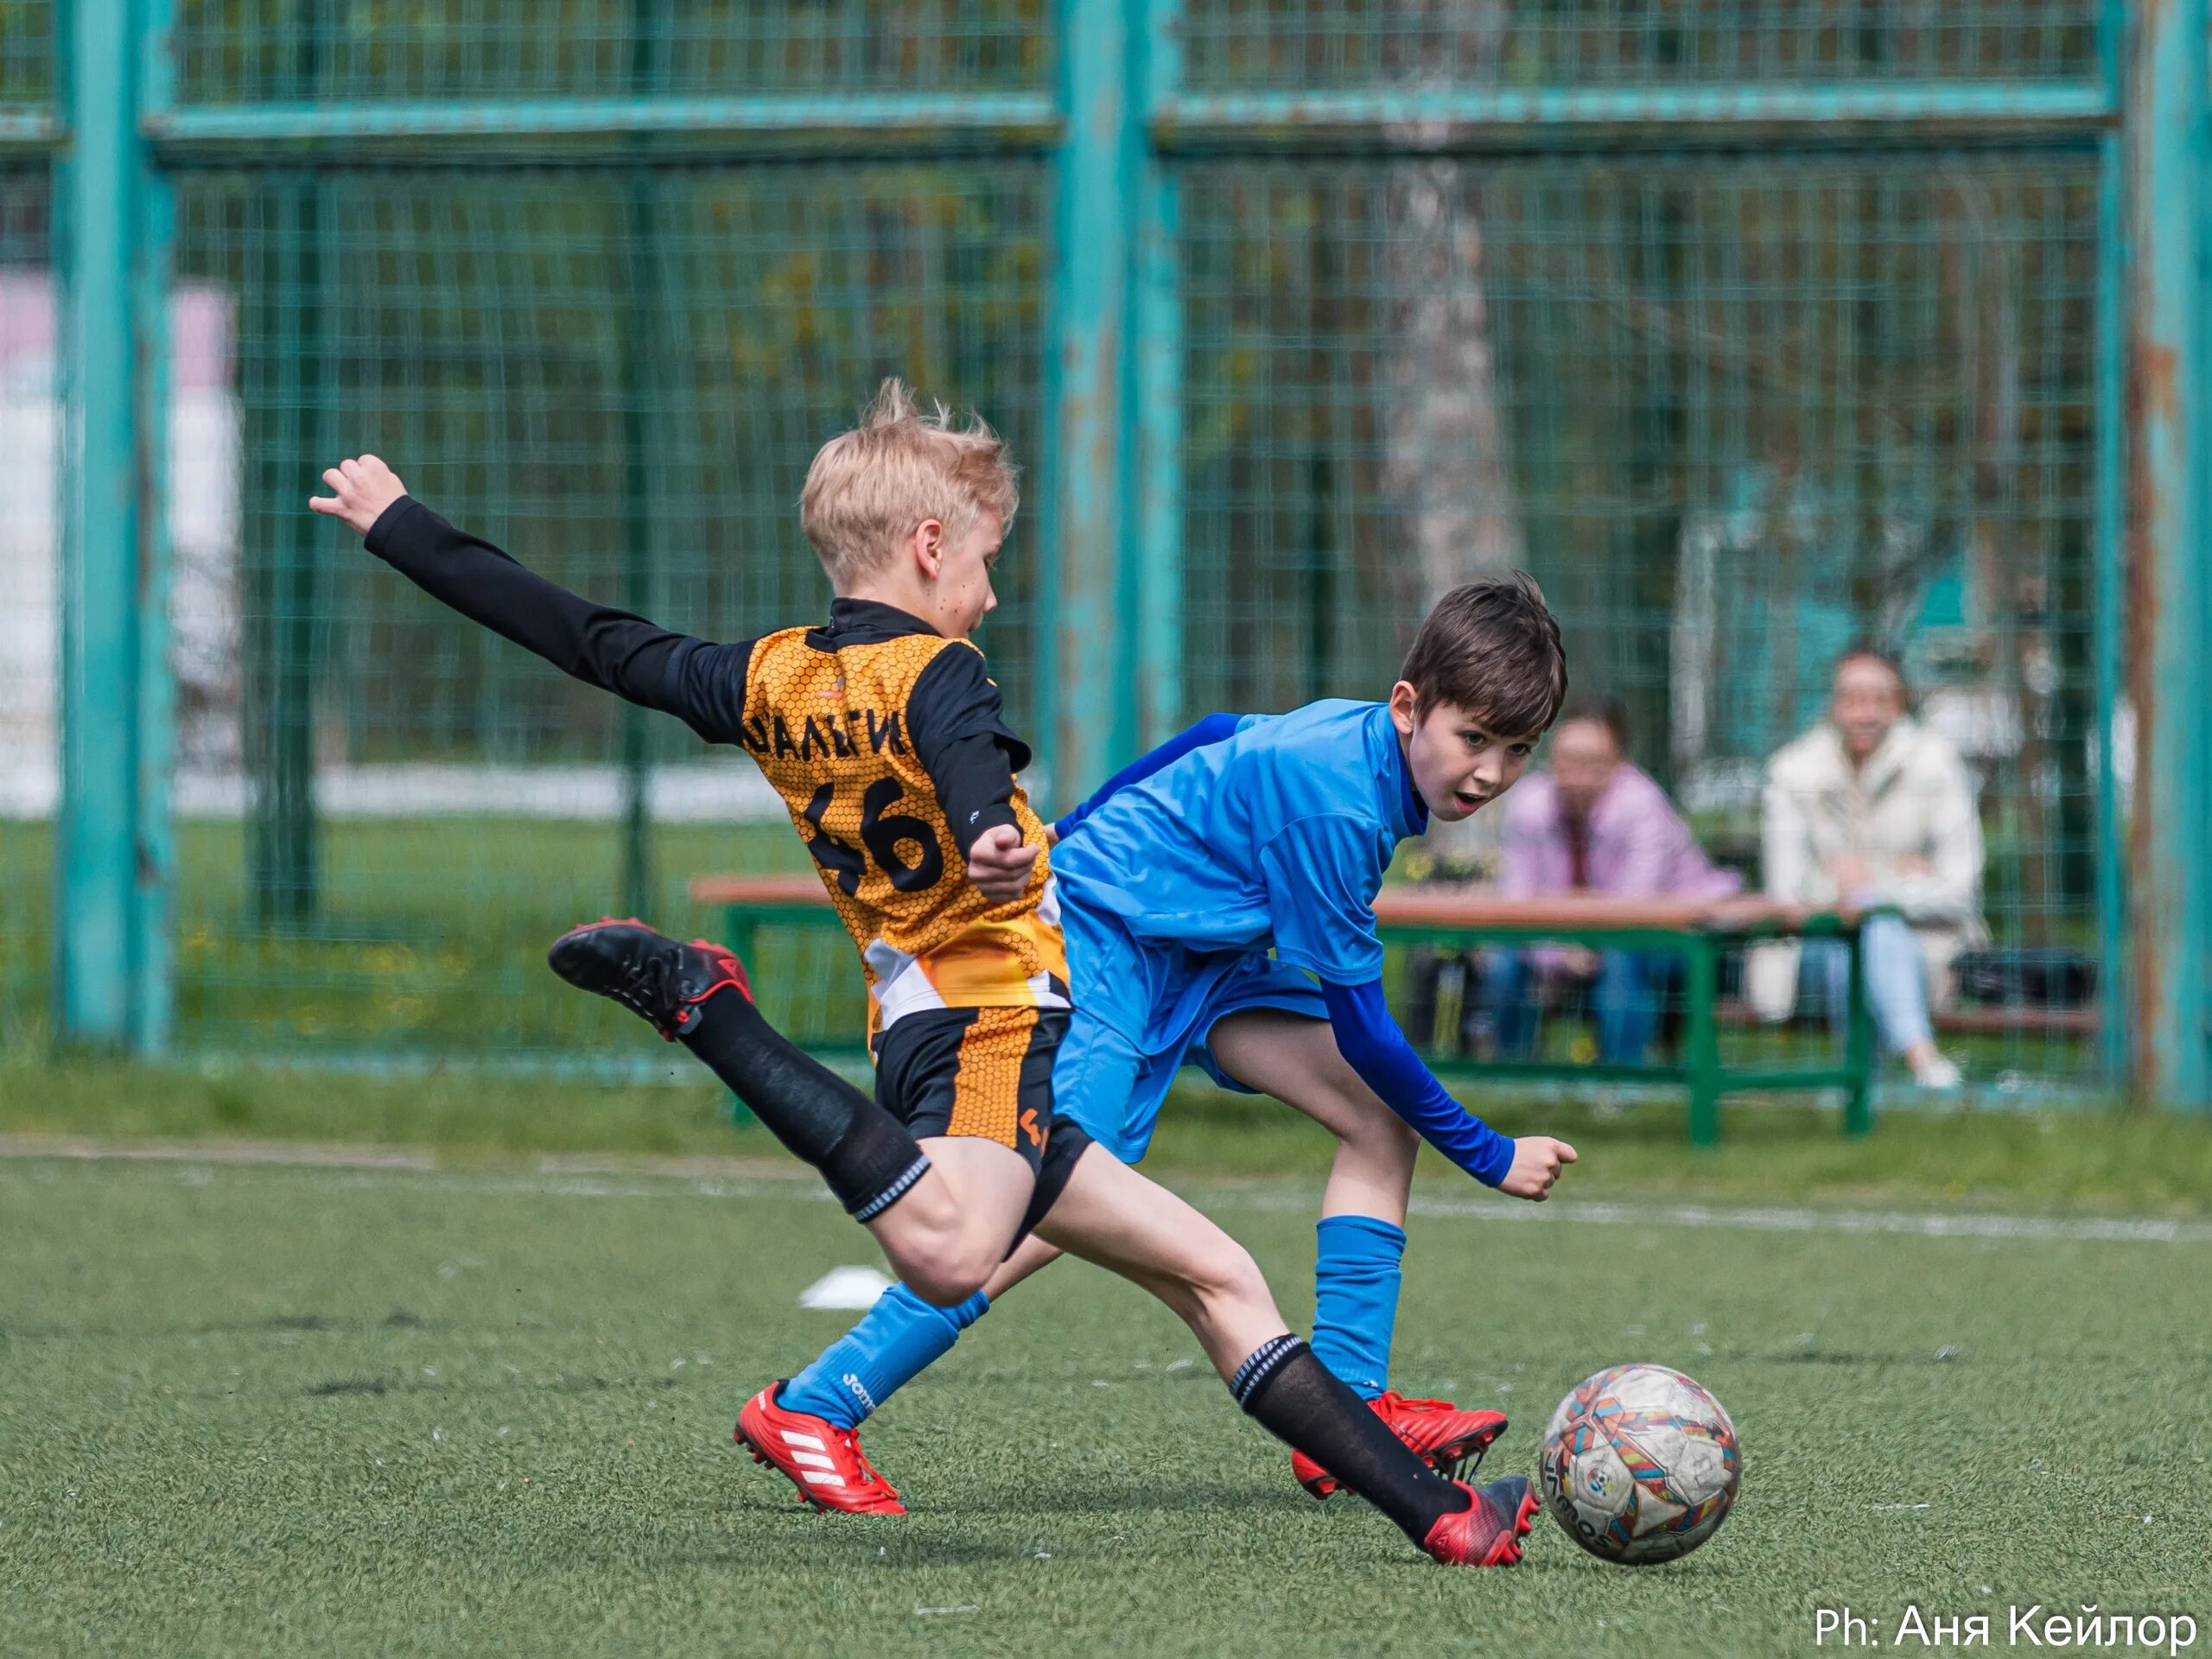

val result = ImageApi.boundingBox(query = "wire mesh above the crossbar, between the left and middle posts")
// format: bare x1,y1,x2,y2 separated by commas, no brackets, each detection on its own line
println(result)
177,0,1051,104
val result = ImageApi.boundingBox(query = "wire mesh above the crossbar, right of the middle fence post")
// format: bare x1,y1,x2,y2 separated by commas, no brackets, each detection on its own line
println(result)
1181,0,2097,91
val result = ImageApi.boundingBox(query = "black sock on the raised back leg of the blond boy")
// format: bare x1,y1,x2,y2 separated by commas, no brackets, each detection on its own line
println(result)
679,991,929,1221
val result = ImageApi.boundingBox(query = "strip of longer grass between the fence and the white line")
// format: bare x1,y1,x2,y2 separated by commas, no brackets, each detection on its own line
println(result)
13,1057,2212,1217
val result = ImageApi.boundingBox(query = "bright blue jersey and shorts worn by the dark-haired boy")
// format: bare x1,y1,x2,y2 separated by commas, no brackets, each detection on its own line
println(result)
1035,702,1513,1185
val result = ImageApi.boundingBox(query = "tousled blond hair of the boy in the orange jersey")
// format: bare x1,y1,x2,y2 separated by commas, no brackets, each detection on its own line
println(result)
798,380,1022,586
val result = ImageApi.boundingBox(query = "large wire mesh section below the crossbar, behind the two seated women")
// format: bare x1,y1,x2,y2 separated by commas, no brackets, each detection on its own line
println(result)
1184,155,2097,1092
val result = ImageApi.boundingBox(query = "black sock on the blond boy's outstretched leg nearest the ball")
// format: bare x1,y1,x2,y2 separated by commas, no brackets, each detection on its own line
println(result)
1230,1334,1473,1544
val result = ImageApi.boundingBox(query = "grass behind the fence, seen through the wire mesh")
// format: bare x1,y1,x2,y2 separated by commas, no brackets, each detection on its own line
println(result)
0,814,2097,1103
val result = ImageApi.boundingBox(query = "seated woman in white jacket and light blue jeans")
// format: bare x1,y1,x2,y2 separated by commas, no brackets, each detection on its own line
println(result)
1745,646,1984,1089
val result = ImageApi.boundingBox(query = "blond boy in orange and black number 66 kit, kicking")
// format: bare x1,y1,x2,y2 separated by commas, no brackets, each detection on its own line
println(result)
312,383,1535,1566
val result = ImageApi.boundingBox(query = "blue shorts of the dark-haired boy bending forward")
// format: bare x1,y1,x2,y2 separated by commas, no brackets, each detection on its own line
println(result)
1053,900,1330,1164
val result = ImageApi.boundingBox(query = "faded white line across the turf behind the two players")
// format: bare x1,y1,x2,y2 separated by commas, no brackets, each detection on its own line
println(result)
0,1135,2212,1245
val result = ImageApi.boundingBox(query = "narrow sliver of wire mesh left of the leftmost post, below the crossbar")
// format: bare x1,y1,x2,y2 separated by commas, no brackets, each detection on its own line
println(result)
0,168,60,1046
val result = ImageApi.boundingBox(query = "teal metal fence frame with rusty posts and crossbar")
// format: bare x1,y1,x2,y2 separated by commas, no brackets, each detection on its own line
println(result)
39,0,2212,1110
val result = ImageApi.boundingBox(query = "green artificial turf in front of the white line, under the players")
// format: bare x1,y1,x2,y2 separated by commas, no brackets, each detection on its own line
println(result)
0,1159,2212,1659
